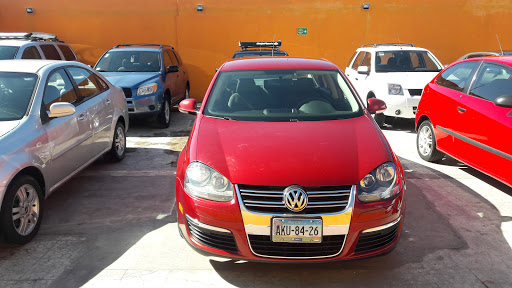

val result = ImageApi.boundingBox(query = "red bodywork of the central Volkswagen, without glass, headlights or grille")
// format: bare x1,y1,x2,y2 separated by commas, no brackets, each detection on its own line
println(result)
176,58,405,262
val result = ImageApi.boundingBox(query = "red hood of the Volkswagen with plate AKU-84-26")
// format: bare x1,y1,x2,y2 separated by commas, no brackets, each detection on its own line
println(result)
195,116,393,187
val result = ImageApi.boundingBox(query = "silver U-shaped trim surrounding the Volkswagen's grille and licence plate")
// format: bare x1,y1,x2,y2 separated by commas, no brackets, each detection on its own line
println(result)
235,184,356,259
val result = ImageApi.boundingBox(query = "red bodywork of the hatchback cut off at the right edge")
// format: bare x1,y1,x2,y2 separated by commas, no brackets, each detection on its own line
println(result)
416,57,512,186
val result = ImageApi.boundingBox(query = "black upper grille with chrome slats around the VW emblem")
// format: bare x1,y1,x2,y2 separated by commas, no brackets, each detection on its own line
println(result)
237,185,352,215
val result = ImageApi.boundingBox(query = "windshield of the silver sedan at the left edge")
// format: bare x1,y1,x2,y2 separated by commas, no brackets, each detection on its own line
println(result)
0,72,37,121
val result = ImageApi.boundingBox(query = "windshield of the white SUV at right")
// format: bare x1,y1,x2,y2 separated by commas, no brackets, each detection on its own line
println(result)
375,50,442,72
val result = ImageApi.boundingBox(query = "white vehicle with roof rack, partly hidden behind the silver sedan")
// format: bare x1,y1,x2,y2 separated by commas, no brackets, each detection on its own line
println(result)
0,32,77,61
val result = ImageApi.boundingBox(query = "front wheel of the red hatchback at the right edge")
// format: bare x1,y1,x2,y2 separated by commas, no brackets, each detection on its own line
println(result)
416,120,444,162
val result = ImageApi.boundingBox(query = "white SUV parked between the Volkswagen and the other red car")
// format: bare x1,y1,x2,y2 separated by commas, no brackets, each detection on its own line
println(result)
345,43,443,127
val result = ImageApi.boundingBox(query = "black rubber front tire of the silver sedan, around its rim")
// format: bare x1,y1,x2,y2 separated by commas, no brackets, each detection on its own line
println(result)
0,175,44,245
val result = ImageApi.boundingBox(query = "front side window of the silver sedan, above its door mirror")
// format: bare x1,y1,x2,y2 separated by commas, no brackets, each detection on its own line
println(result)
43,69,78,110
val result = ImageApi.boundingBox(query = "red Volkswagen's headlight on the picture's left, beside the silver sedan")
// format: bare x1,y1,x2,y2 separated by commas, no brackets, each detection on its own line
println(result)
185,162,234,202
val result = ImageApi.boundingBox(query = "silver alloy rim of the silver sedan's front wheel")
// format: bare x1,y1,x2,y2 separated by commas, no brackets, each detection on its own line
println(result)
12,184,39,236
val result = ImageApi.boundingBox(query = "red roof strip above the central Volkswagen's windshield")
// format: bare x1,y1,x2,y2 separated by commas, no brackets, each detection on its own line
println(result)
221,57,339,71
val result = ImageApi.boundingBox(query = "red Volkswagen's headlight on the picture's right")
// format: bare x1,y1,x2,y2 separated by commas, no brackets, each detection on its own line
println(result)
357,162,401,202
